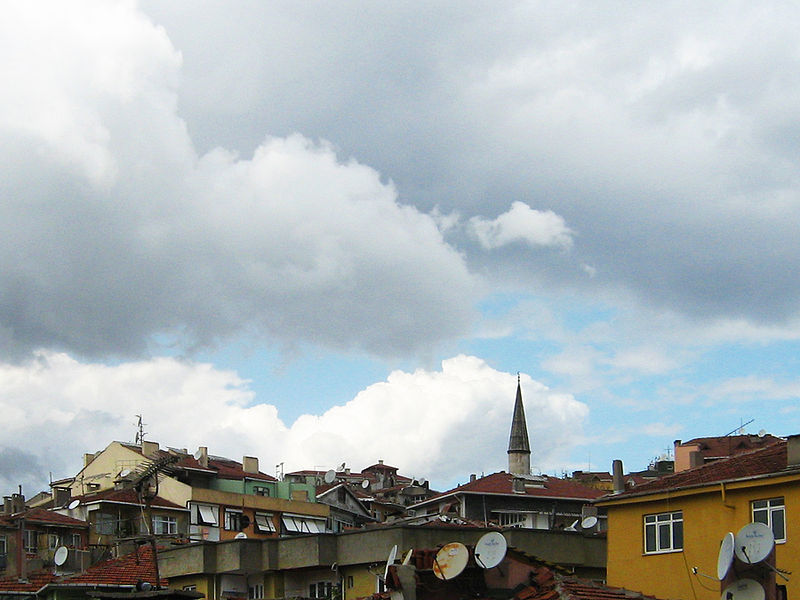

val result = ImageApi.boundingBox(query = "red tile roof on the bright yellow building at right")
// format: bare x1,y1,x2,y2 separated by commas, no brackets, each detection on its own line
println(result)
602,440,800,502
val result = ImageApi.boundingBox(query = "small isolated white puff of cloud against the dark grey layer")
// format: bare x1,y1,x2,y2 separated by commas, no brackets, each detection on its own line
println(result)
469,201,572,250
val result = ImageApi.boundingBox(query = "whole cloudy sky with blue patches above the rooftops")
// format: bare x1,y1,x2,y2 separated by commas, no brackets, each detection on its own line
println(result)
0,0,800,496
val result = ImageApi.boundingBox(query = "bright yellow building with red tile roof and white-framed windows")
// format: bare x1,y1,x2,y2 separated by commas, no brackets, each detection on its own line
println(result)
597,435,800,600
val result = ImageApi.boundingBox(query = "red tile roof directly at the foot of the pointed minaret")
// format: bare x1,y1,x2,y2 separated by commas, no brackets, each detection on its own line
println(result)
419,471,605,504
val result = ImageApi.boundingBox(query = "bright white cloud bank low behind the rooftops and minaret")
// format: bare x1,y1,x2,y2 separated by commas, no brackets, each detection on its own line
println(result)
0,352,588,493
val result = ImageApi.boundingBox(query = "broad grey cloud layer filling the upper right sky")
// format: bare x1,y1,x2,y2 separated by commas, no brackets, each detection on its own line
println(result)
138,2,800,329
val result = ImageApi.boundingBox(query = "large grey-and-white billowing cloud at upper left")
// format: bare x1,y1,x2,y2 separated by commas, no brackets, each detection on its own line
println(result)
0,1,477,358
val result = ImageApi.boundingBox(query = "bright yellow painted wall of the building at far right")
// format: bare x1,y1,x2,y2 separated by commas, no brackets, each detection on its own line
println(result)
600,477,800,600
